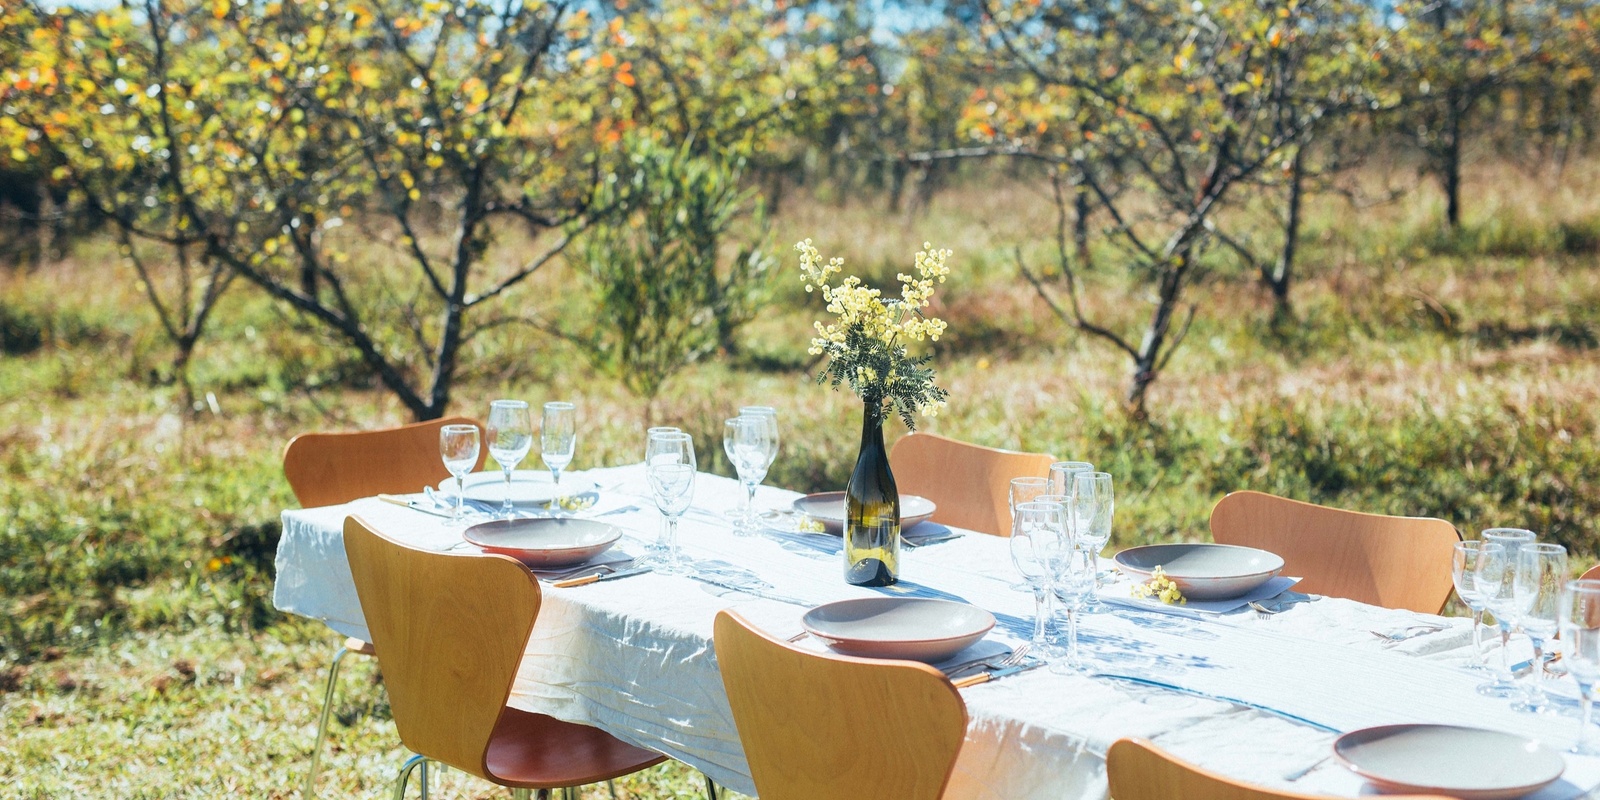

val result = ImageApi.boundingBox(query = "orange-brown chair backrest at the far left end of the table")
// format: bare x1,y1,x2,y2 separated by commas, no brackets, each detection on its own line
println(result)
283,416,488,509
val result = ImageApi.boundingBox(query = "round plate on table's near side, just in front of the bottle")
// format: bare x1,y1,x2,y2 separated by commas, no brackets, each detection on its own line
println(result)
800,597,995,664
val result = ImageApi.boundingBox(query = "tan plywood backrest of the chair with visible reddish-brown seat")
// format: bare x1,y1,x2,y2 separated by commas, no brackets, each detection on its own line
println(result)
344,517,539,779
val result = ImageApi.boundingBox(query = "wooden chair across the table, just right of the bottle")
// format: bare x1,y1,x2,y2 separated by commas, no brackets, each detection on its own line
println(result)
890,434,1056,536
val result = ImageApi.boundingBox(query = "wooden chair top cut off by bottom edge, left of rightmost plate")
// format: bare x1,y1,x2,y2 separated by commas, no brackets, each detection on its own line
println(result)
1106,739,1446,800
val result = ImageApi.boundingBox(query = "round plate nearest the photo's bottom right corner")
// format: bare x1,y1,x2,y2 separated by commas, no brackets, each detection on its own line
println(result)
1333,725,1566,800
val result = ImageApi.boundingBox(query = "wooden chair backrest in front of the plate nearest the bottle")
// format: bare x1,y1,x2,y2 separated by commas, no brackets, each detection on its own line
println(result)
715,611,966,800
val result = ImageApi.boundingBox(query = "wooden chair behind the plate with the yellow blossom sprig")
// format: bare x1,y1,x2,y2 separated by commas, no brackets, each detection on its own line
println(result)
1211,491,1461,614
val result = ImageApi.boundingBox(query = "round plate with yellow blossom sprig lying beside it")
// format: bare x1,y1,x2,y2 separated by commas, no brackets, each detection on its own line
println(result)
1117,544,1283,600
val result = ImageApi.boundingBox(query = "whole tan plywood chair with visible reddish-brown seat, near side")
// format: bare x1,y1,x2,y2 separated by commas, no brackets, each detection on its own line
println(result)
344,517,666,800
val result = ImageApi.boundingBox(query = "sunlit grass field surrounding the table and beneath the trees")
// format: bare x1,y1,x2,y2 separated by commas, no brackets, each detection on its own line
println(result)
0,163,1600,797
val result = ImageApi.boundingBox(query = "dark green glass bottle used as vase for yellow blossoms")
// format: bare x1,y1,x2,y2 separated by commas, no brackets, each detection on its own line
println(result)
845,402,899,586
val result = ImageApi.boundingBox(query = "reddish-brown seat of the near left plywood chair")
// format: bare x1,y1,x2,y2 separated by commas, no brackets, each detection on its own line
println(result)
483,707,667,789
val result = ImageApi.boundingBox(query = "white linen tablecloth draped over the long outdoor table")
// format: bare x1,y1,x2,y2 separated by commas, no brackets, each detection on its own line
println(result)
274,466,1600,800
